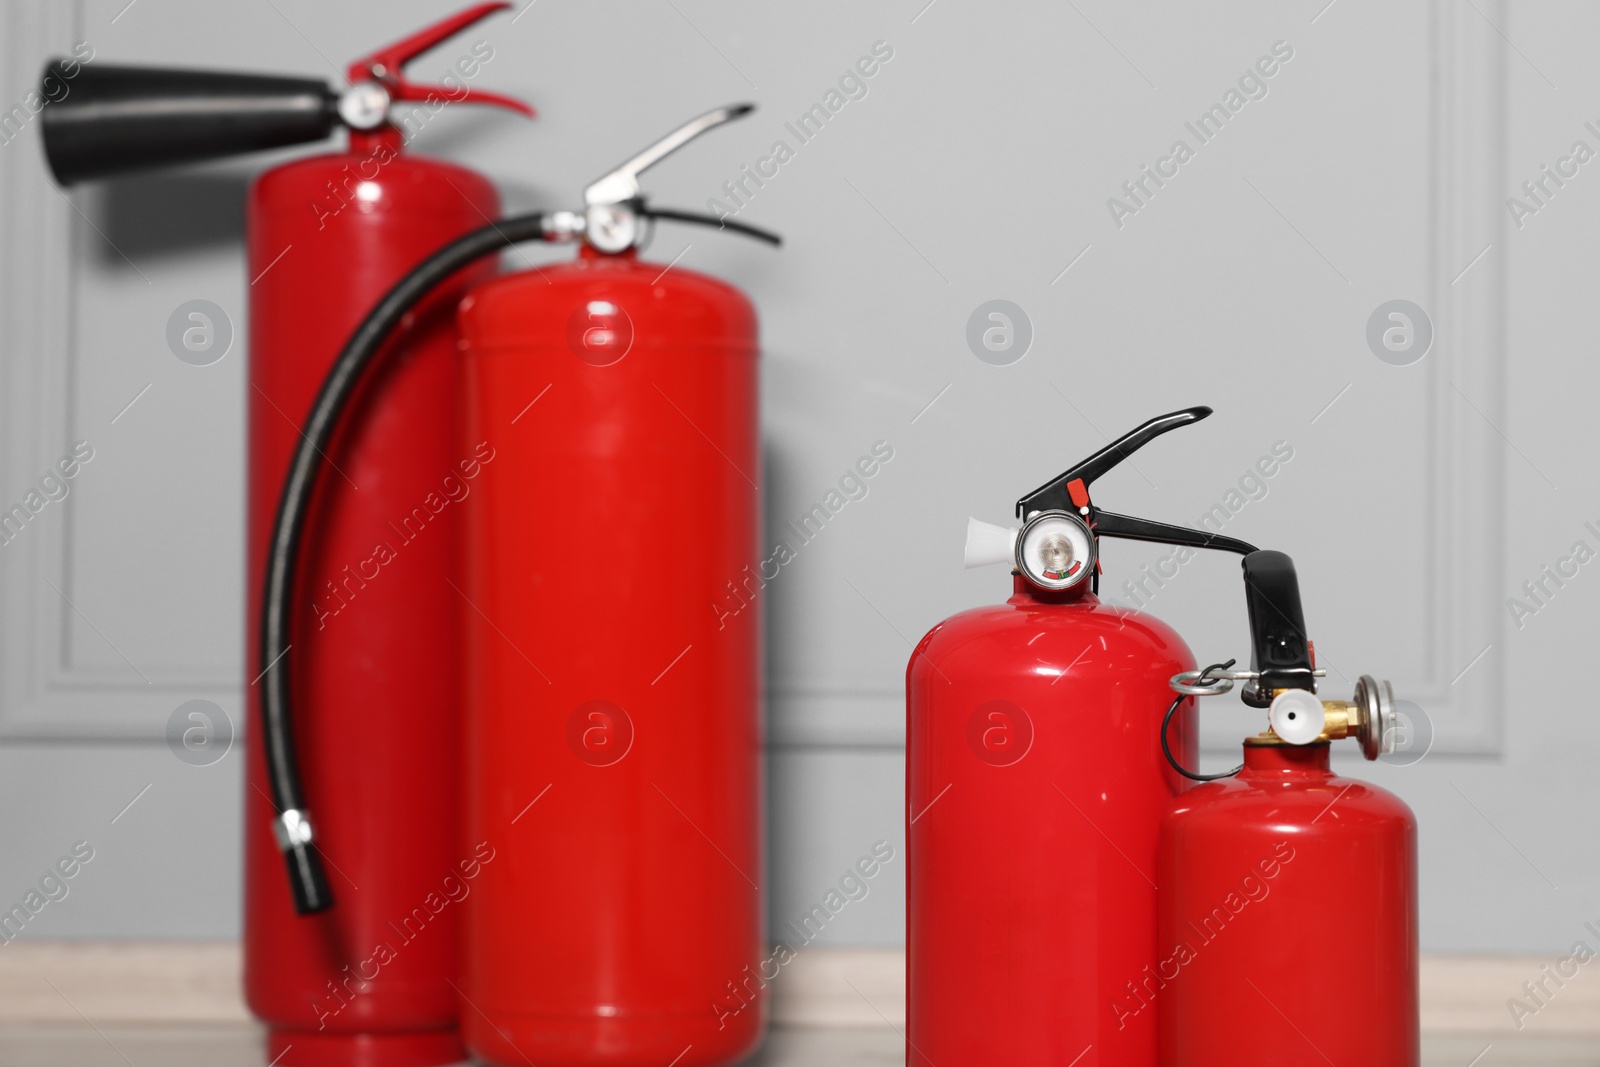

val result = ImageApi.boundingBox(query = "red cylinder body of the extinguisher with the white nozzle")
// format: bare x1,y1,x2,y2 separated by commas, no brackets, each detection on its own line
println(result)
906,577,1194,1067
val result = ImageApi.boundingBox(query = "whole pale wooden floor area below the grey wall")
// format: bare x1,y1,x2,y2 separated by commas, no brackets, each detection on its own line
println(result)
0,939,1600,1067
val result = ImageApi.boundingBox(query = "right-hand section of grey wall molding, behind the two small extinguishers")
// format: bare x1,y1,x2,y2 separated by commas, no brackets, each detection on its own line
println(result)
768,0,1509,755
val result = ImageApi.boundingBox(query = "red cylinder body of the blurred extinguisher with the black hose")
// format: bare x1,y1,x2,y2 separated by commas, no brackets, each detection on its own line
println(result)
461,248,765,1067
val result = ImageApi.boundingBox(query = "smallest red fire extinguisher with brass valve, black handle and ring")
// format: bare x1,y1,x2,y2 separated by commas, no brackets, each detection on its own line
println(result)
1152,552,1421,1067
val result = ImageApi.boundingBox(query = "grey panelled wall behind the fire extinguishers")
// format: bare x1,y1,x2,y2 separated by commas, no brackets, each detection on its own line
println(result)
0,0,1600,950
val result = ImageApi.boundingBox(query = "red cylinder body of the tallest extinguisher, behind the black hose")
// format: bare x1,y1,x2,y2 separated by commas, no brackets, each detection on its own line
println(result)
245,133,499,1067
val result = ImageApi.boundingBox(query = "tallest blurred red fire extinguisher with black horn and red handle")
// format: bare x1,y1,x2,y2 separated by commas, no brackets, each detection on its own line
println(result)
43,3,533,1067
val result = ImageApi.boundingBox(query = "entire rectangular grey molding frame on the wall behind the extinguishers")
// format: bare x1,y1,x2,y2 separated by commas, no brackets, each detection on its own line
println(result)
0,0,1507,755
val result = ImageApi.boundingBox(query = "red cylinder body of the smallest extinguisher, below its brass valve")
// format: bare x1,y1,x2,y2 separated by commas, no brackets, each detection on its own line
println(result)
1158,742,1421,1067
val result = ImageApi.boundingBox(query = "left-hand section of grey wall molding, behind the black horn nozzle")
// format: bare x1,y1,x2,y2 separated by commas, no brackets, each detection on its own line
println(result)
0,0,240,741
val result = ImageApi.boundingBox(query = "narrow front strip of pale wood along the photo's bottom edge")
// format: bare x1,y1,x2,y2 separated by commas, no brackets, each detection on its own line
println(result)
0,1025,1600,1067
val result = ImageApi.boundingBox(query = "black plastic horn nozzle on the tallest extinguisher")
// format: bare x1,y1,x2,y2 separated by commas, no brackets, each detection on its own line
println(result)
40,59,339,186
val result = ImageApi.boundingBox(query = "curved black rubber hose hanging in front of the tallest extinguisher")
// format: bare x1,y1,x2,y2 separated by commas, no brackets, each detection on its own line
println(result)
261,214,546,915
